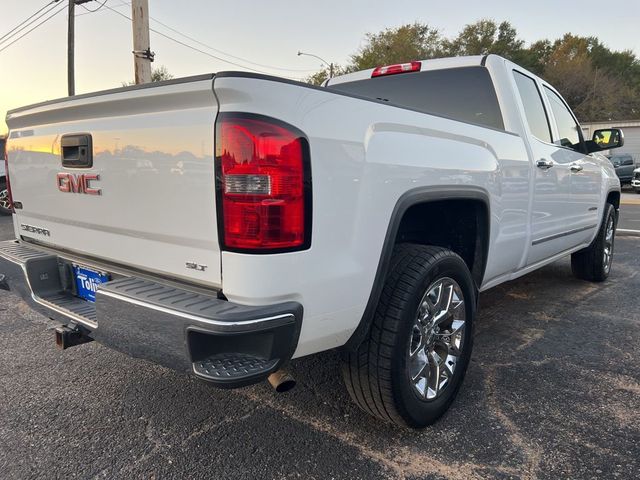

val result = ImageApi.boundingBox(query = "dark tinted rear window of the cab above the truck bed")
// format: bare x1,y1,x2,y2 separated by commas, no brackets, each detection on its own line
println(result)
328,66,504,130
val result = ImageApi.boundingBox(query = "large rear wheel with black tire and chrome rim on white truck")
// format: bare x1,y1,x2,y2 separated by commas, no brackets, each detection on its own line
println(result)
342,244,476,428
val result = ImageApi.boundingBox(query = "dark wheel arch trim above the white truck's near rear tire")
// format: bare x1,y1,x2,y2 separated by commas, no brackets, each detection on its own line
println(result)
344,185,491,350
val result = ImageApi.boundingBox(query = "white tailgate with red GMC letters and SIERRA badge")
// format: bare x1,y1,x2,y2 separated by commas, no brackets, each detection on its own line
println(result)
7,75,221,287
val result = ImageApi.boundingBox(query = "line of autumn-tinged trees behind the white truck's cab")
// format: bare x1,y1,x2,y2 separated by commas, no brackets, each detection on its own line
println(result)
307,19,640,122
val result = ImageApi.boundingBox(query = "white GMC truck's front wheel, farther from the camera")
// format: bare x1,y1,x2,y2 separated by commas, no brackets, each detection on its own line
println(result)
571,203,617,282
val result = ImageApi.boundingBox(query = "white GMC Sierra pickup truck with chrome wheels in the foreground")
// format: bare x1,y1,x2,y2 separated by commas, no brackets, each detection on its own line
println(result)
0,55,623,427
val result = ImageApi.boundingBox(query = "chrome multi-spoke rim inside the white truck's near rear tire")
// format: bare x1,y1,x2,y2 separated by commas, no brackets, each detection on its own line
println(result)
408,277,466,400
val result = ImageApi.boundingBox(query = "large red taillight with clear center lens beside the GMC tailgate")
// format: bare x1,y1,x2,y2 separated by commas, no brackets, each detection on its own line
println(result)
216,114,311,252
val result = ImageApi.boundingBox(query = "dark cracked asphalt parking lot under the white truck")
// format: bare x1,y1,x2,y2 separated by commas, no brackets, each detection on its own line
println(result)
0,217,640,479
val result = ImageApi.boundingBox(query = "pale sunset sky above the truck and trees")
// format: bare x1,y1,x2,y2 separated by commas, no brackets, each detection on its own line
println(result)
0,0,640,134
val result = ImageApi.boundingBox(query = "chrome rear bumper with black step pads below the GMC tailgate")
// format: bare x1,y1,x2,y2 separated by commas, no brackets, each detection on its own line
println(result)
0,241,302,388
